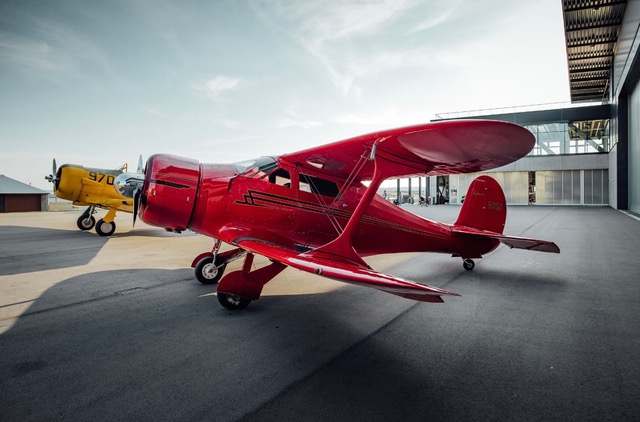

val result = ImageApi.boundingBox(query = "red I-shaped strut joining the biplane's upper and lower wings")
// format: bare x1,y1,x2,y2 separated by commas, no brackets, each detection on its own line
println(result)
304,142,389,268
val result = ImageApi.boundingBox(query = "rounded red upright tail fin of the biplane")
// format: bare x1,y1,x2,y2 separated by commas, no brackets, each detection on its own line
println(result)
456,176,507,233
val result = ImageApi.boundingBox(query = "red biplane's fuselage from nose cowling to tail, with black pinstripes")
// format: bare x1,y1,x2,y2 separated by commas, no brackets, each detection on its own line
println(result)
139,154,499,258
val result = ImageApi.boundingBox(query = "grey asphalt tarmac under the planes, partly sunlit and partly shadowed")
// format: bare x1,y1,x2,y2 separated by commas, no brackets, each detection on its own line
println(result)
0,205,640,422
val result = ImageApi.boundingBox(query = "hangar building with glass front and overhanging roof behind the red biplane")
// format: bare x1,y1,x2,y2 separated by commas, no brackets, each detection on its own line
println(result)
398,0,640,214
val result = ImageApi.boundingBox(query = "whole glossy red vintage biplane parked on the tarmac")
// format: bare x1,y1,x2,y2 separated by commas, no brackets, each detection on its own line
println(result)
123,120,560,309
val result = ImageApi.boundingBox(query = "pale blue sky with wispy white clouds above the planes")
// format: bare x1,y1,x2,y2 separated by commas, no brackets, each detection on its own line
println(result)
0,0,570,190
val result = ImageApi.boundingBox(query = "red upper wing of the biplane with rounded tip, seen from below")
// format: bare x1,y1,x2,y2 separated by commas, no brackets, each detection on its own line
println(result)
280,120,535,180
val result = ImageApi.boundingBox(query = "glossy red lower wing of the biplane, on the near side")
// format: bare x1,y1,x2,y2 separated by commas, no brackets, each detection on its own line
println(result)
238,240,460,303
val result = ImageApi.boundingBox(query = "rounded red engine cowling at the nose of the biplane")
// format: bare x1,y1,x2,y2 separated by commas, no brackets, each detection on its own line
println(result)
138,154,200,232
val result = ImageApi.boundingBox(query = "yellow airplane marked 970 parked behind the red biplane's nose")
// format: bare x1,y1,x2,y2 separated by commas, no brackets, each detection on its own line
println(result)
45,156,144,236
